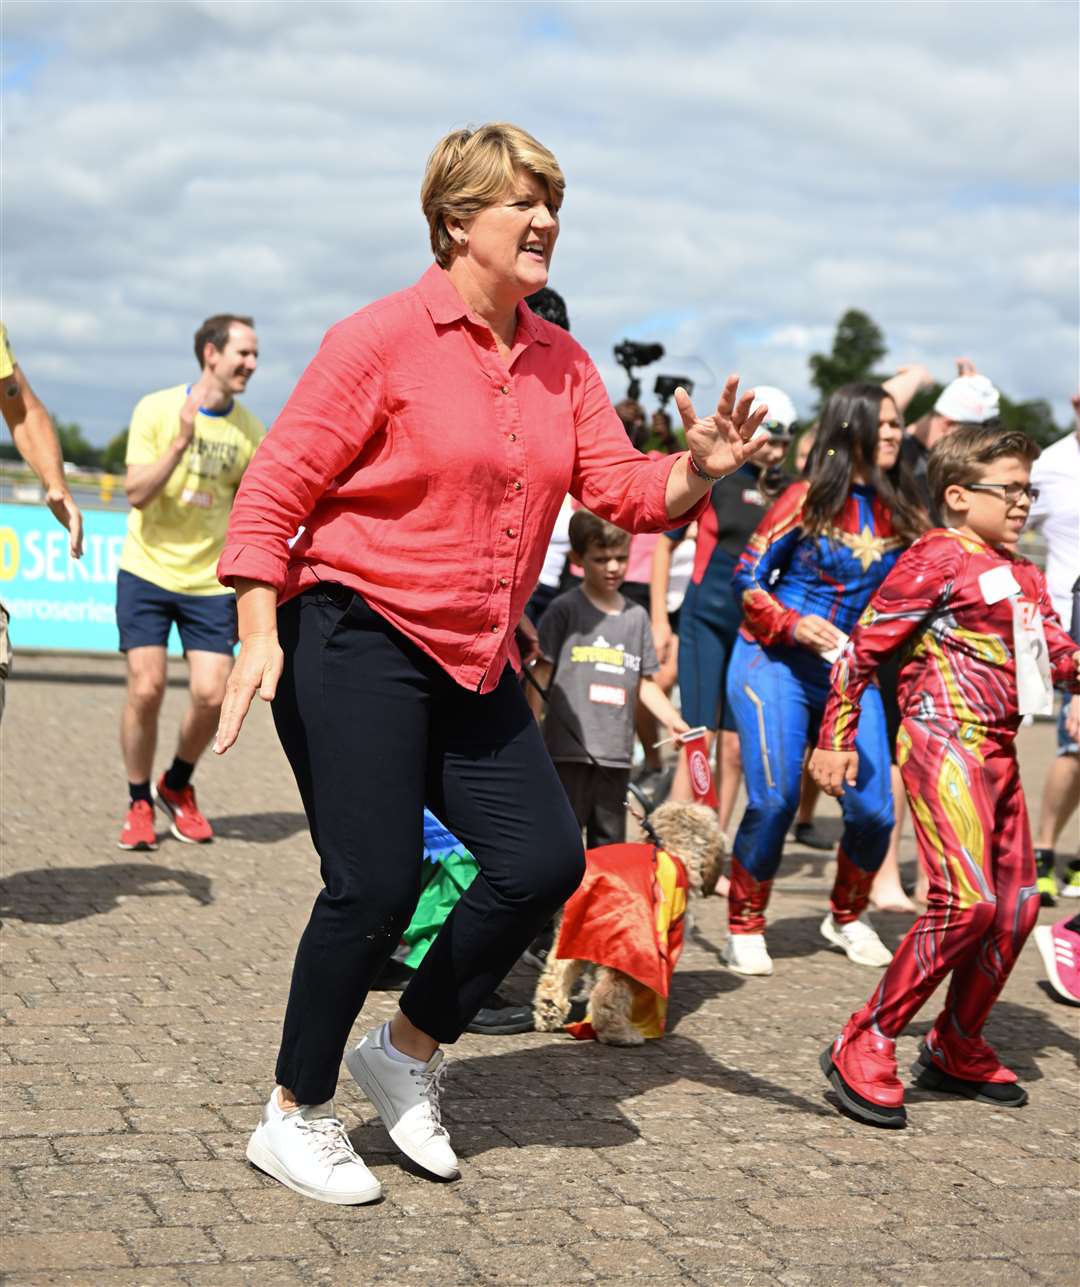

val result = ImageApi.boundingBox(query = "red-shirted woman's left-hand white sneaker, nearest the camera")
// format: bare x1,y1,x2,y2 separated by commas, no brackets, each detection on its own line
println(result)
247,1091,382,1205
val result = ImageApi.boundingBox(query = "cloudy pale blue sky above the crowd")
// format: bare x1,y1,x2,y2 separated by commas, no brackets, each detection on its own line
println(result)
3,0,1080,443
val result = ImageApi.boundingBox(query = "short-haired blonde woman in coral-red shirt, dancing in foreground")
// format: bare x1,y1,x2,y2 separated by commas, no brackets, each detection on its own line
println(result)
215,125,767,1202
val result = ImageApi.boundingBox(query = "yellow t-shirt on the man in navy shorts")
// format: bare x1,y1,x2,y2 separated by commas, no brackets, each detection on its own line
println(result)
120,385,265,595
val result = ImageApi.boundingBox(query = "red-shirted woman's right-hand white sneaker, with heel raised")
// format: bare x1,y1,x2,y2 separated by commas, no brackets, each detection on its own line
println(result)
345,1023,461,1180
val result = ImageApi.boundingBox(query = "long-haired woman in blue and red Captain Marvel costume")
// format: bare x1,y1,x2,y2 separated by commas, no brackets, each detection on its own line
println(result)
723,384,927,974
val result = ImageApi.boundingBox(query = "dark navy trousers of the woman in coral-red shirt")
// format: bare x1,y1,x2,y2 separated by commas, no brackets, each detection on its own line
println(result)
273,583,584,1103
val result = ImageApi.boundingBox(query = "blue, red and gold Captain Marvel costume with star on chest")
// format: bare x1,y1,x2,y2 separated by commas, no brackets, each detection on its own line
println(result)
727,481,906,934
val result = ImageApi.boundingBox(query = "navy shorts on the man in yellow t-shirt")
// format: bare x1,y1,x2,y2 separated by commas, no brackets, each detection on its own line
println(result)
116,569,237,656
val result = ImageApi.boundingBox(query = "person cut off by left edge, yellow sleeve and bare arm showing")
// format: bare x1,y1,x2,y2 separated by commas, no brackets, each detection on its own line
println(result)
0,322,82,716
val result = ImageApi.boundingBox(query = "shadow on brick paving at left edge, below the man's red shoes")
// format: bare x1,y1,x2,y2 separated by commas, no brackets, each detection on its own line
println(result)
0,862,214,925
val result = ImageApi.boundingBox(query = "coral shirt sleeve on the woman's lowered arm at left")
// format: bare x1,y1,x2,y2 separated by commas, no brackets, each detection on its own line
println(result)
218,315,386,591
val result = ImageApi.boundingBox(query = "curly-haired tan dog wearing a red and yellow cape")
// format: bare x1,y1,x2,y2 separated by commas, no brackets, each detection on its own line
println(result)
533,802,723,1045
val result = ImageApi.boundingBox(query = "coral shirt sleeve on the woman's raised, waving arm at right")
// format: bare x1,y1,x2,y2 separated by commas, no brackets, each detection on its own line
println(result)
570,350,709,532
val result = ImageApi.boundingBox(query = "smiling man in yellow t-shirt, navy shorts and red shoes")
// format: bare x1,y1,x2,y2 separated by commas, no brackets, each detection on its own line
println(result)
116,313,264,849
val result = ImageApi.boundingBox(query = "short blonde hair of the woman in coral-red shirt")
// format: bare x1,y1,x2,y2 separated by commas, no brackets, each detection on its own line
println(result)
420,121,566,268
